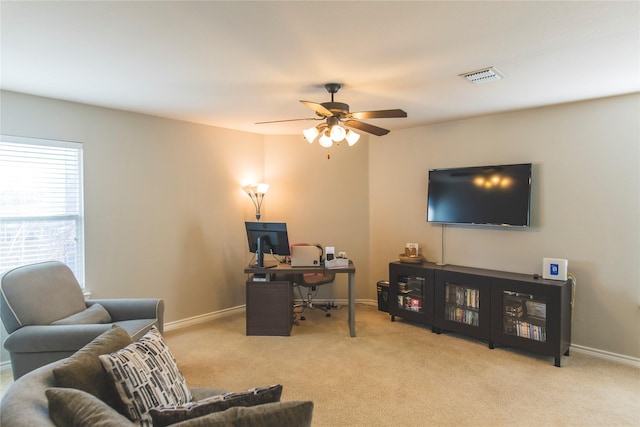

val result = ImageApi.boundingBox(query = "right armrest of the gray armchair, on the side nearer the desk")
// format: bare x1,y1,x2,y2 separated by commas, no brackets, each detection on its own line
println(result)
87,298,164,333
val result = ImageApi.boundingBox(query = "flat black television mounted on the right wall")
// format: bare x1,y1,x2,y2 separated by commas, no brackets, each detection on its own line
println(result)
427,163,531,227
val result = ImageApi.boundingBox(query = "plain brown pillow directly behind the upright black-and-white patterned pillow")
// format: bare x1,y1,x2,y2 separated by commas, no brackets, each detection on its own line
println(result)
53,325,132,413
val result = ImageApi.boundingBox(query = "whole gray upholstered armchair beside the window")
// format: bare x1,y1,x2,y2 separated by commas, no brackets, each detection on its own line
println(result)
0,261,164,379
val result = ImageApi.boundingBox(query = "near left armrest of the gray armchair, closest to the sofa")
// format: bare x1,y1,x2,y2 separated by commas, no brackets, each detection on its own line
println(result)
4,323,112,353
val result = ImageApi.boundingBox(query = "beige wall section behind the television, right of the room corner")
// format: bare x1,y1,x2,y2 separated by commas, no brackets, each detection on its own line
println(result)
369,94,640,358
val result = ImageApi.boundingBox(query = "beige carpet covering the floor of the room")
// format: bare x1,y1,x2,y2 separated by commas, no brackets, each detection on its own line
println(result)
166,305,640,427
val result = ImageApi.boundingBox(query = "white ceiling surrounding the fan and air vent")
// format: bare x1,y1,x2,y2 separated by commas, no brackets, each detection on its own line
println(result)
0,0,640,134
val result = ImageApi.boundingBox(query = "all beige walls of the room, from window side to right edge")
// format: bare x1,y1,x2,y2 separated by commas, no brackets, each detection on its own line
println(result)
0,92,640,360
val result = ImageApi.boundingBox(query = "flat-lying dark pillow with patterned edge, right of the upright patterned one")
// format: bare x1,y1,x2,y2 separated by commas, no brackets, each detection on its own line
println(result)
149,384,282,427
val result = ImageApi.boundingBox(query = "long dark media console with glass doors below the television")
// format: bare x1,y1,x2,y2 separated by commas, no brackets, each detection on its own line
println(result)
389,261,573,367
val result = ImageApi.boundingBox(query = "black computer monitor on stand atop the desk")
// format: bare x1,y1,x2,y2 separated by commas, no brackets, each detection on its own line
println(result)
244,222,291,268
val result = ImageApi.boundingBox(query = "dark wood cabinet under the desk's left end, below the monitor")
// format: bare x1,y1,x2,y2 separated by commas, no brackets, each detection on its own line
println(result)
246,281,293,336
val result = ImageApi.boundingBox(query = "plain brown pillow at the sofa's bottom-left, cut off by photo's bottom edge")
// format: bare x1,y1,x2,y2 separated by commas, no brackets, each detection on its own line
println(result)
45,388,131,427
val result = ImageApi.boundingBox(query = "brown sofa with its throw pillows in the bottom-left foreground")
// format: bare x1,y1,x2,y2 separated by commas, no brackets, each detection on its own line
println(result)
0,327,313,427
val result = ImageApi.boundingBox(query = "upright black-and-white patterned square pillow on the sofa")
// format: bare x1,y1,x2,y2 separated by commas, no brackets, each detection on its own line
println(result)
99,326,191,426
